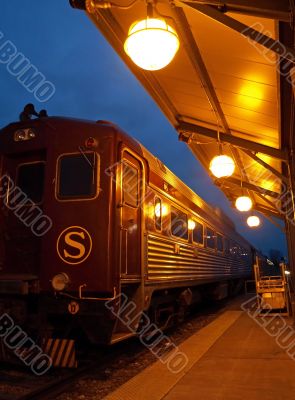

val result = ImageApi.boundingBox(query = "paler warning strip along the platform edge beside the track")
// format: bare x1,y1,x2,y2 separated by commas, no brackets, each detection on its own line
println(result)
104,311,242,400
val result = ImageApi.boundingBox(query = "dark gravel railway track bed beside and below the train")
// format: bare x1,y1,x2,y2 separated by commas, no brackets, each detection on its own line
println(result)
0,299,243,400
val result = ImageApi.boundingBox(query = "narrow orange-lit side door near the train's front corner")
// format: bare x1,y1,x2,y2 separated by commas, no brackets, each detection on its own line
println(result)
120,150,143,279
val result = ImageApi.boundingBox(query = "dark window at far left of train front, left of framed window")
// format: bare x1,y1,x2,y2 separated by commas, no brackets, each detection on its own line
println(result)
16,162,45,204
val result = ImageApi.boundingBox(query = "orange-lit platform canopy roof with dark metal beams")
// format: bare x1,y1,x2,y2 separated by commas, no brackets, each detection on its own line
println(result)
72,0,295,225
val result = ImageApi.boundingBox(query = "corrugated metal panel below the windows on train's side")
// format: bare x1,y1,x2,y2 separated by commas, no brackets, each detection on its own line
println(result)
147,235,251,281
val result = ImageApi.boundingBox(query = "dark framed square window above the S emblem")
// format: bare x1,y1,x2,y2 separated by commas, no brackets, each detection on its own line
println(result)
57,152,98,199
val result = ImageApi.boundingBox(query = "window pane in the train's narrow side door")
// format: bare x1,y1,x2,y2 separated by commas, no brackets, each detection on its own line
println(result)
122,161,139,207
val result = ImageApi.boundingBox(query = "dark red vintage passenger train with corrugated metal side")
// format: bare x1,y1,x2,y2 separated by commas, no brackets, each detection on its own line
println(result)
0,107,255,343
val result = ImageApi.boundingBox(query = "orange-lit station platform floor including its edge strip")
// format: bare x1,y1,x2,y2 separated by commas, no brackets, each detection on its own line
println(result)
105,299,295,400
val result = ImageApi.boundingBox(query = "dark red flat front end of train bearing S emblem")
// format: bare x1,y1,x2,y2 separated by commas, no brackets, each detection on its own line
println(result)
0,114,119,343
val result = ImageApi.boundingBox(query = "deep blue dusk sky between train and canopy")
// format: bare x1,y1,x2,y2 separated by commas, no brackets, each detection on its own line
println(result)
0,0,287,255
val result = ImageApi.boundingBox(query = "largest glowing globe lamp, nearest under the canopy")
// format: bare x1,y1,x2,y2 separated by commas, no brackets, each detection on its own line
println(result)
124,18,179,71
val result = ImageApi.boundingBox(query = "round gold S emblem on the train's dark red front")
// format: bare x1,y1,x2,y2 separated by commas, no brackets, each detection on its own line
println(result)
56,226,92,264
